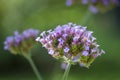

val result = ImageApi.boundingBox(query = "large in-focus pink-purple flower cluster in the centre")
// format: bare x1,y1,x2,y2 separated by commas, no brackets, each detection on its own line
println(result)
36,23,104,67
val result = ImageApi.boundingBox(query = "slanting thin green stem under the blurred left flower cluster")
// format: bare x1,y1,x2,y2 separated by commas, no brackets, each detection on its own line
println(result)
24,54,42,80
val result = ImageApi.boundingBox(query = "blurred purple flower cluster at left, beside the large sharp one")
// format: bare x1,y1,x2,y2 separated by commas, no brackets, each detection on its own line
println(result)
4,29,39,54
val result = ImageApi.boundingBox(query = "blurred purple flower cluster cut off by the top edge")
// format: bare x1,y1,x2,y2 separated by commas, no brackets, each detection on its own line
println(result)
66,0,120,13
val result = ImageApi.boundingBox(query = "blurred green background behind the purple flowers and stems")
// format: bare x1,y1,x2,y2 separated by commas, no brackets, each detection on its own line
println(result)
0,0,120,80
